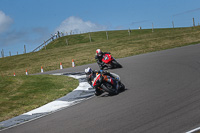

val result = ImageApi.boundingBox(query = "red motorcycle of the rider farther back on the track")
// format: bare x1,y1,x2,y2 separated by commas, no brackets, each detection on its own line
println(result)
97,54,122,70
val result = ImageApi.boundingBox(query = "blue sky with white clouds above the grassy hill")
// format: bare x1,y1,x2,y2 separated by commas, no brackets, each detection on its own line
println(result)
0,0,200,57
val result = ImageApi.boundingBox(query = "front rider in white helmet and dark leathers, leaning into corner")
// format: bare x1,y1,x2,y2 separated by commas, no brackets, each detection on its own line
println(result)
85,67,119,96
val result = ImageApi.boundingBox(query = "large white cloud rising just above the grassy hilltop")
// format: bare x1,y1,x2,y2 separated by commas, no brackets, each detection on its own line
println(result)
55,16,107,33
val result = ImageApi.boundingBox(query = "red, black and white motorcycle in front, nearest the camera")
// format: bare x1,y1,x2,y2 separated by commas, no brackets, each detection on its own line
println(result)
92,73,125,95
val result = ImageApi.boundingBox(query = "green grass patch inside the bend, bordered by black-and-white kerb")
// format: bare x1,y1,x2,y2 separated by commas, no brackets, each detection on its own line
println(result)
0,75,79,121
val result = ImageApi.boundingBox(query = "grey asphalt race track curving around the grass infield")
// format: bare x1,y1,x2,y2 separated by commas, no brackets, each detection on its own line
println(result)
2,44,200,133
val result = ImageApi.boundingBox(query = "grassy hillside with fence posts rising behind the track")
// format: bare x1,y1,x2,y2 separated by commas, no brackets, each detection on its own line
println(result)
0,27,200,76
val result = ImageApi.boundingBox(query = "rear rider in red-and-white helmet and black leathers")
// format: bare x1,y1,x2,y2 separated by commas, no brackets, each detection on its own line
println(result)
95,49,110,69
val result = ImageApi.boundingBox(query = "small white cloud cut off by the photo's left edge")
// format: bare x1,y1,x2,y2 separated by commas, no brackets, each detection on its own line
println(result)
0,11,13,33
